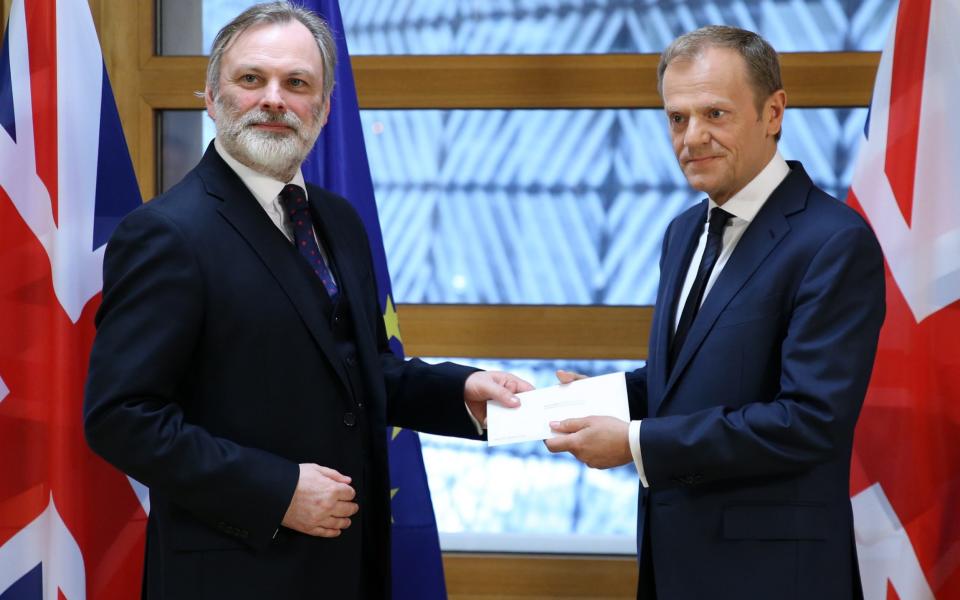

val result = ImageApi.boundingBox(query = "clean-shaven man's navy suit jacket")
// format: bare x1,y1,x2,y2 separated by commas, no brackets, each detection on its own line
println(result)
628,162,884,600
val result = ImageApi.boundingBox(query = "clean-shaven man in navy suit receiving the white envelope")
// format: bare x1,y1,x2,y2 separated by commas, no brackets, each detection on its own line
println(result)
547,27,885,600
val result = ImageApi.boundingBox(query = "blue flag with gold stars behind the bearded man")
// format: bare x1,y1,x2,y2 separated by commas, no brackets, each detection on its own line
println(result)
302,0,447,600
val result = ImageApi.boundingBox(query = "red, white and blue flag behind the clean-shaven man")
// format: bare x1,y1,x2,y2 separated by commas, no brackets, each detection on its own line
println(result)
849,0,960,600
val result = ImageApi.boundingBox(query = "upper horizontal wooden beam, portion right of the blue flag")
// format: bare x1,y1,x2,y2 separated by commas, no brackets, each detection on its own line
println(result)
353,52,879,108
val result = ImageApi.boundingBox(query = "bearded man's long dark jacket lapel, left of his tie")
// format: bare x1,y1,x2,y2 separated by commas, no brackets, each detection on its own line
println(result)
199,144,350,390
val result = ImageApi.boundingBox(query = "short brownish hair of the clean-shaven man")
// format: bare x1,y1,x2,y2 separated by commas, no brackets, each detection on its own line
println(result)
657,25,783,140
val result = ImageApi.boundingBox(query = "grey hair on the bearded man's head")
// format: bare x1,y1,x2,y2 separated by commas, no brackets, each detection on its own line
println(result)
207,2,337,100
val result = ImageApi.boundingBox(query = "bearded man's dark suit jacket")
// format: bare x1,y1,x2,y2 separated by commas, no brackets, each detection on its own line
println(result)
84,145,476,600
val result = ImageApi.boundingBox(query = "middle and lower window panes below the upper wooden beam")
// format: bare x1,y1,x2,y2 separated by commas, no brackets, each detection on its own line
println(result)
162,103,866,553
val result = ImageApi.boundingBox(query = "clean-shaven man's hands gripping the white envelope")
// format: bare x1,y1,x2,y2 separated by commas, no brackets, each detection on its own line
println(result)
543,371,633,469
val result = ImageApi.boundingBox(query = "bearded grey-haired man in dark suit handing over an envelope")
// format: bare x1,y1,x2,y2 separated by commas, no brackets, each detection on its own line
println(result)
84,2,530,600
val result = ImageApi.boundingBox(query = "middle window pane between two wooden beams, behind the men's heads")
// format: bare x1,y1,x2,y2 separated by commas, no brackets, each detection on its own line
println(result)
161,108,867,305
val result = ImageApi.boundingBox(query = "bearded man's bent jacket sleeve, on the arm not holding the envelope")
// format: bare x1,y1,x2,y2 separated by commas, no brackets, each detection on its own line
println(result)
83,205,299,546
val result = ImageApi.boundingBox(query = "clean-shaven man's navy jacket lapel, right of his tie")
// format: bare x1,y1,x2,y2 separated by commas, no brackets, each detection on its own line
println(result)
651,161,812,414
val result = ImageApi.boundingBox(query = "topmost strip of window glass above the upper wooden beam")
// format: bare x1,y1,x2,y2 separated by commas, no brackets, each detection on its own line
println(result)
159,0,897,55
